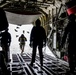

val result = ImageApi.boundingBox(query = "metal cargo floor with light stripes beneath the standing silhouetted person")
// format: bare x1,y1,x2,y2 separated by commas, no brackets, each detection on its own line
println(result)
8,53,69,75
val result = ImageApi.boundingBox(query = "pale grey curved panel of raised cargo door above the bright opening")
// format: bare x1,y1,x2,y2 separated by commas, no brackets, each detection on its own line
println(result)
6,11,41,25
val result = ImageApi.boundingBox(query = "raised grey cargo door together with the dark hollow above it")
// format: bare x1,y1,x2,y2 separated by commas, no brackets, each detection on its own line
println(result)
4,1,41,25
